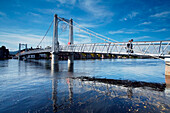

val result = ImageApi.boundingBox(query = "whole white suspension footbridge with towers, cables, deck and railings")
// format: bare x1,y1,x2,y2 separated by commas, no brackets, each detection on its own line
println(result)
18,14,170,64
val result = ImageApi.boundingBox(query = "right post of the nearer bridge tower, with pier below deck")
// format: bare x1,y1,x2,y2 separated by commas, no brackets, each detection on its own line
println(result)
68,19,74,67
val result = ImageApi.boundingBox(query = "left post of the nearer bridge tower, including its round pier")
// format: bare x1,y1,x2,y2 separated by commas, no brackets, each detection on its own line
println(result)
51,14,59,64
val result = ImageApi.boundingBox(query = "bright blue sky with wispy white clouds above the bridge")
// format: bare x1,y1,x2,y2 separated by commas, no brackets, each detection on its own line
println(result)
0,0,170,51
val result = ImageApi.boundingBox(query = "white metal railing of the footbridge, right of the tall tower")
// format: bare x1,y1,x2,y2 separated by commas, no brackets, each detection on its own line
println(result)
59,41,170,57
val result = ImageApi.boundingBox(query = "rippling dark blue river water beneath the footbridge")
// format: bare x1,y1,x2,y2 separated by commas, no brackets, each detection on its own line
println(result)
0,59,170,113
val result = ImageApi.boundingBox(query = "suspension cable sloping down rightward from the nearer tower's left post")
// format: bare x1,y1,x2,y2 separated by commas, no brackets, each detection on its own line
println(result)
58,17,111,42
